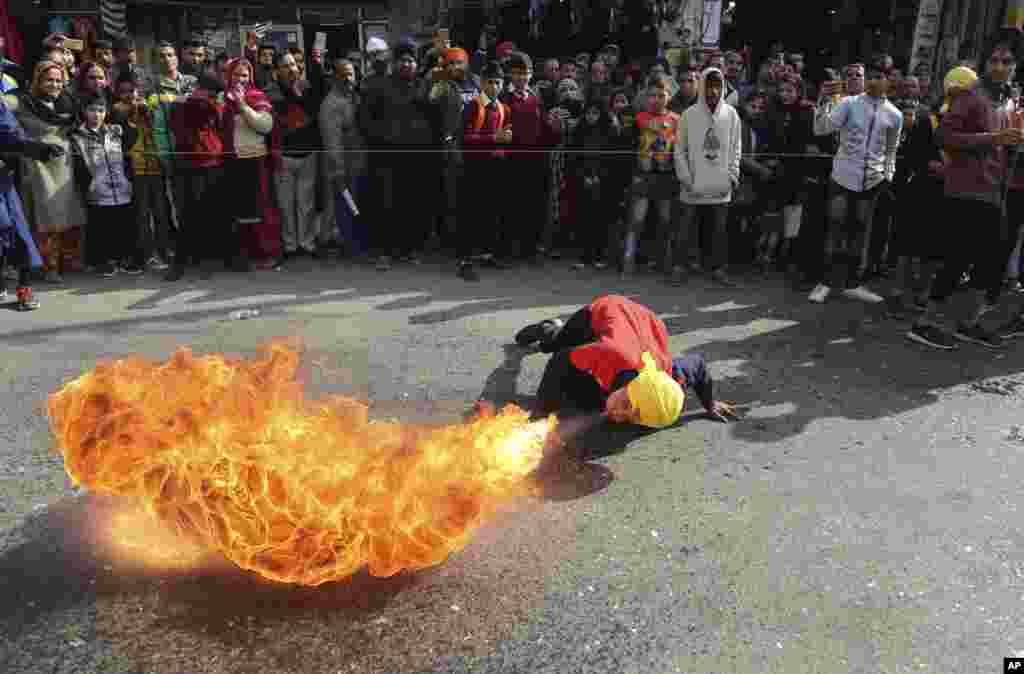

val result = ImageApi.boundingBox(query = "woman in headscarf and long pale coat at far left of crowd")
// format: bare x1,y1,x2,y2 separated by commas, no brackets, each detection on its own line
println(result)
4,60,86,283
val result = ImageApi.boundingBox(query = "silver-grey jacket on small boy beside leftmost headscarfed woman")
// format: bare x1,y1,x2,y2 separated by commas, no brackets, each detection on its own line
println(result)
71,124,136,206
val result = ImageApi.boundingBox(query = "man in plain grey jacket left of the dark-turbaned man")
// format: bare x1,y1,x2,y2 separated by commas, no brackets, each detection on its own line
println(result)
319,57,368,257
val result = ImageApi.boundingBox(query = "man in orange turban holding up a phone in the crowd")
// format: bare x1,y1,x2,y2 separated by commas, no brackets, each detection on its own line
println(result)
430,47,480,258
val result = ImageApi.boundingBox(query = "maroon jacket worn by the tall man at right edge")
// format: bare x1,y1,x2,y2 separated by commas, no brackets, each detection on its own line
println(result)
939,82,1016,206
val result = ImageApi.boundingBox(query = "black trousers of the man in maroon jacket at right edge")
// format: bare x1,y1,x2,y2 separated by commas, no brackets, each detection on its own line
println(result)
932,198,1003,304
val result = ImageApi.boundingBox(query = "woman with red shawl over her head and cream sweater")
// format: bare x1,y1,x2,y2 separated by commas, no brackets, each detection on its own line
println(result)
223,58,281,271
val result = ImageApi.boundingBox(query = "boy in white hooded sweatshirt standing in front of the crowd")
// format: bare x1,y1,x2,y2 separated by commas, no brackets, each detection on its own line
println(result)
670,68,743,285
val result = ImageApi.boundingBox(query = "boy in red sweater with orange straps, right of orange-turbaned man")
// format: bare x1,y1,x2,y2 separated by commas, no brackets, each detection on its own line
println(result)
457,58,512,281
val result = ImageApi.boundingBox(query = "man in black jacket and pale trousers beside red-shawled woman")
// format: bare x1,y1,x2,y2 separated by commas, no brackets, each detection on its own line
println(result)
266,51,322,260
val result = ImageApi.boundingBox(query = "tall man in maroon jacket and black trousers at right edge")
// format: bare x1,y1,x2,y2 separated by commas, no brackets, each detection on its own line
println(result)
906,31,1024,350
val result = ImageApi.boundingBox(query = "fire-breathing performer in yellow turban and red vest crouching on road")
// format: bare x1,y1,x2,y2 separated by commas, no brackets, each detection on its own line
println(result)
515,295,736,428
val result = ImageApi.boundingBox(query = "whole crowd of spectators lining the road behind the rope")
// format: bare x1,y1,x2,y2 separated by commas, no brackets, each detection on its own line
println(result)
6,18,1024,349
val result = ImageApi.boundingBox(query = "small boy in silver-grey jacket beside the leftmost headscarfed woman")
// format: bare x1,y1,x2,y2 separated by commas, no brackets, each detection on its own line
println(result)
71,97,142,279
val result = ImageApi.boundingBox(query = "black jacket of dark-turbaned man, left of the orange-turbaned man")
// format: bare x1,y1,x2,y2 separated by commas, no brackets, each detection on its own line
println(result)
359,75,435,149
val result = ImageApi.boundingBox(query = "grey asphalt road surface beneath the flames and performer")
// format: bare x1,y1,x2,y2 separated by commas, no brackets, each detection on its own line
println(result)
0,255,1024,674
